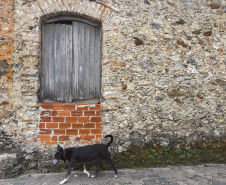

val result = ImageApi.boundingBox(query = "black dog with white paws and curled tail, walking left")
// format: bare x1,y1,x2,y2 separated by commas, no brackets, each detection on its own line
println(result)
52,135,117,184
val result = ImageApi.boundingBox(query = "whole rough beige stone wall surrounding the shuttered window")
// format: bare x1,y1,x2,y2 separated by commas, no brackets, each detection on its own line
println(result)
0,0,226,178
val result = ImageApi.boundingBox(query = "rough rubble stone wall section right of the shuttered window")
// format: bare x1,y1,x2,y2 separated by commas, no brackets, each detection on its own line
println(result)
102,0,226,148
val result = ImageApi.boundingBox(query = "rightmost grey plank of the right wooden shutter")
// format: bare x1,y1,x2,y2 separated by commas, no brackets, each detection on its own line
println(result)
94,27,101,98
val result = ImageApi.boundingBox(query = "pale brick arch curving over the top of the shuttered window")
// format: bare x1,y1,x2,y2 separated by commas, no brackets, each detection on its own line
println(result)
30,0,112,23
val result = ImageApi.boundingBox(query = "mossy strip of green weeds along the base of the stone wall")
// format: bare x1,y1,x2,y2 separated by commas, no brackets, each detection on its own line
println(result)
47,141,226,172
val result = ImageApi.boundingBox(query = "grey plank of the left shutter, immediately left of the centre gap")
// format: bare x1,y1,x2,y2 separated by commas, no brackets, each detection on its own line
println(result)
65,25,72,102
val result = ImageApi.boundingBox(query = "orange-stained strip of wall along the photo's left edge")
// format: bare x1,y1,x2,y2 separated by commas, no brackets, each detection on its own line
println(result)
0,0,14,131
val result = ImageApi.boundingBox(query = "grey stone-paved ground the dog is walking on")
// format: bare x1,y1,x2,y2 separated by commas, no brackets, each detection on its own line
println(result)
0,164,226,185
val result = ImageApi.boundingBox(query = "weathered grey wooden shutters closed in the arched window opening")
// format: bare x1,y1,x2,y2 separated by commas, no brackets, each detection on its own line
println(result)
40,19,101,102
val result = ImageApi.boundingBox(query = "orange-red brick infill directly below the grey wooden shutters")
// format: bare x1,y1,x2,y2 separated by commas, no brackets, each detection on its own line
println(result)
39,103,102,145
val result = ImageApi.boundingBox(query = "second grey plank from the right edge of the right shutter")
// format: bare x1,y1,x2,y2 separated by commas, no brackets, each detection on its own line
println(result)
89,26,96,99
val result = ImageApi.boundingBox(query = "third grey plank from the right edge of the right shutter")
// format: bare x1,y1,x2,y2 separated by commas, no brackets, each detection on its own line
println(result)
83,24,91,99
